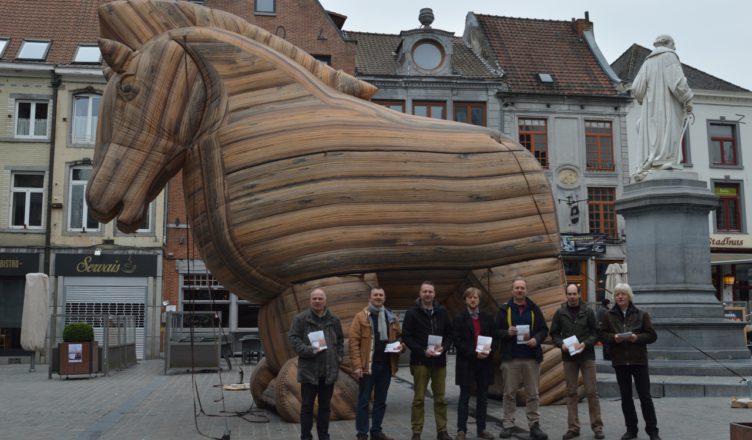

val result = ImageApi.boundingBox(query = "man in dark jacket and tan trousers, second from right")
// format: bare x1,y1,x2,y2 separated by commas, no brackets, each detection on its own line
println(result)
551,284,606,440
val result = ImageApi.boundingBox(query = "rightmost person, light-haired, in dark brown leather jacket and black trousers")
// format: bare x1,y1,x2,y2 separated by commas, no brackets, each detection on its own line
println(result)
600,284,660,440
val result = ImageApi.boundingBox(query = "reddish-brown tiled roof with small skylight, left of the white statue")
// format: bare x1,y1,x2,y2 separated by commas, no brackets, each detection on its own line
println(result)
475,14,619,96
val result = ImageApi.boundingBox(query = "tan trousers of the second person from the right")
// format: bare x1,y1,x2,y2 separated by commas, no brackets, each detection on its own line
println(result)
562,359,603,432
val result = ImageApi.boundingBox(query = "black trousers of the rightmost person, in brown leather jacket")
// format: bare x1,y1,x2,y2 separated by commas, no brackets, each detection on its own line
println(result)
614,365,658,434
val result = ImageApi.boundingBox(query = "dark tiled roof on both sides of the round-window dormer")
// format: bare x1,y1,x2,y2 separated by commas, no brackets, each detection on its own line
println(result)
346,31,499,78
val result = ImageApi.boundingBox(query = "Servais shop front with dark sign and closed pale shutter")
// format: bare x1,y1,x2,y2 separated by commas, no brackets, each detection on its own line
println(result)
55,250,161,359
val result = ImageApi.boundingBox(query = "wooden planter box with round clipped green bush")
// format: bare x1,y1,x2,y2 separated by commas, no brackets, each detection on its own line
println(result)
58,322,99,376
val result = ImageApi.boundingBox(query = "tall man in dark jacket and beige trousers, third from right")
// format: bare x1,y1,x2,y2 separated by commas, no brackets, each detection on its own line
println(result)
496,277,548,440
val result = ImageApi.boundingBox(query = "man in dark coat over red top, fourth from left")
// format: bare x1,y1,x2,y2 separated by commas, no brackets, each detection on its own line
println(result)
452,287,496,440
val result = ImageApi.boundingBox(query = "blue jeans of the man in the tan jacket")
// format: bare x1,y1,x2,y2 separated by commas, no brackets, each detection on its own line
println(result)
355,360,392,435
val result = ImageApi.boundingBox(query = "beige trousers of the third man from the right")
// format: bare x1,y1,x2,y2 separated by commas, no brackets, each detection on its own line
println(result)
501,359,540,428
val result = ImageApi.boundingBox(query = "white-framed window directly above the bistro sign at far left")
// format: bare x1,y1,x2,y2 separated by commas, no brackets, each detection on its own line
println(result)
10,173,44,229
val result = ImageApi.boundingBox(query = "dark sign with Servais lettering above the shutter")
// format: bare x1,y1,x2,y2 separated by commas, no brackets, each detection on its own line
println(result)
55,254,157,277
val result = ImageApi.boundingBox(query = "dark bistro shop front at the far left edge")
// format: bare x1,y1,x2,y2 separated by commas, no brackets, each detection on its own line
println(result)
0,252,41,356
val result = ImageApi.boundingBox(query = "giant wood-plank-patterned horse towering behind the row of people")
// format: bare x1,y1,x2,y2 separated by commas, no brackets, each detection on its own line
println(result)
87,0,564,420
